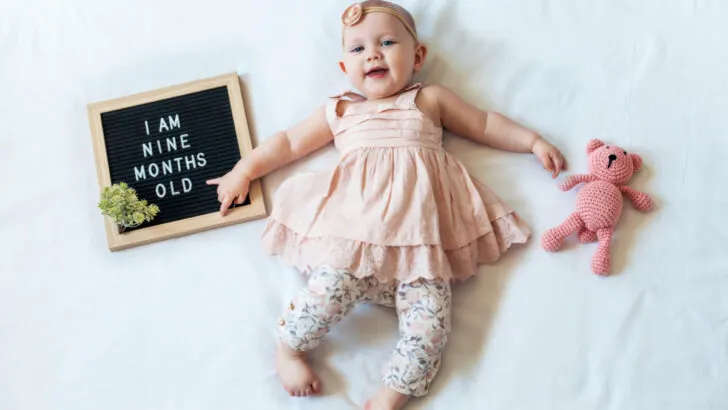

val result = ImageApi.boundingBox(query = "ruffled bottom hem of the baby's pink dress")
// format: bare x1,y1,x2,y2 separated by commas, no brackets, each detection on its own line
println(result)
262,213,531,283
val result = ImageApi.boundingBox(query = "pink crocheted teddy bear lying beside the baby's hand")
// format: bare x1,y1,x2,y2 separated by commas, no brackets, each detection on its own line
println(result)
541,139,652,276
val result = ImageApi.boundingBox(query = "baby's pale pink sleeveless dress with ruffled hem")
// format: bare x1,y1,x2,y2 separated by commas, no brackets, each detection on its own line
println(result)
262,84,530,282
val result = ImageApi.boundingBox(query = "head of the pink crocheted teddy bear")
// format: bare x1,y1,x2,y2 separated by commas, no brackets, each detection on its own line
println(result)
586,140,642,185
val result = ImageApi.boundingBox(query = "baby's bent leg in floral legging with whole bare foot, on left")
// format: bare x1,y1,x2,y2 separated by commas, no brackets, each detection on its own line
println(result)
276,268,368,396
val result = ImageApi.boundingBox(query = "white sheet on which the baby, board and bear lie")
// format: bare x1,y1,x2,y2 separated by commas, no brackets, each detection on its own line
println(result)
0,0,728,410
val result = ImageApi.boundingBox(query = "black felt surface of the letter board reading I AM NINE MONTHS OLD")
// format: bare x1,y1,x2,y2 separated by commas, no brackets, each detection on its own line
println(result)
101,86,250,228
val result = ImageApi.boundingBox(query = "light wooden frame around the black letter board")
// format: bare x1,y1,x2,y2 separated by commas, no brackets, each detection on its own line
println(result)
88,73,267,251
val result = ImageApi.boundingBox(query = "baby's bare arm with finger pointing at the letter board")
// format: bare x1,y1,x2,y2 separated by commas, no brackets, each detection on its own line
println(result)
207,106,334,216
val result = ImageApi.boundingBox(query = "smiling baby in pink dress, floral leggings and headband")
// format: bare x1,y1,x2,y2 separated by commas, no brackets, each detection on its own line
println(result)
208,0,565,409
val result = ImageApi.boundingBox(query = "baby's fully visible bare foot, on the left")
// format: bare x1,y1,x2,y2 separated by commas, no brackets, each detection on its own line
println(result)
276,344,321,397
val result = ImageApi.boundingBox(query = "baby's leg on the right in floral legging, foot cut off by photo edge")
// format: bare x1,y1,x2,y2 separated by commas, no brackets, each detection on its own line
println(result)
366,280,451,409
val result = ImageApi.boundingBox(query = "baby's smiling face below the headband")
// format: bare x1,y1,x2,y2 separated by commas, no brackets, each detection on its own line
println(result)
340,13,426,99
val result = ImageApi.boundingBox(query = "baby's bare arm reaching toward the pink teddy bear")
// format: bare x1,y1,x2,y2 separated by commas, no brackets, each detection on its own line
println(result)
422,85,566,177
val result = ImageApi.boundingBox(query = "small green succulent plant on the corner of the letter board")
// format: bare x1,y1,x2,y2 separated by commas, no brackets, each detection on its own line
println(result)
98,182,159,232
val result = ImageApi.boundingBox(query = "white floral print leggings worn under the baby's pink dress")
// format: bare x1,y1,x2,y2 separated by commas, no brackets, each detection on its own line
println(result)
278,267,451,397
